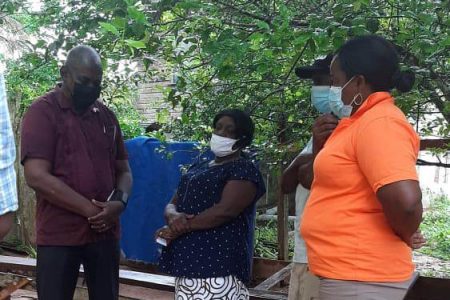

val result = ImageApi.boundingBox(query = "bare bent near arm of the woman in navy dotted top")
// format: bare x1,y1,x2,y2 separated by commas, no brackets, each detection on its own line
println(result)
187,180,257,231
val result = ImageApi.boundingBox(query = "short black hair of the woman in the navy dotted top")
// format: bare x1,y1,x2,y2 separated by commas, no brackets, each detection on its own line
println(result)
213,108,255,148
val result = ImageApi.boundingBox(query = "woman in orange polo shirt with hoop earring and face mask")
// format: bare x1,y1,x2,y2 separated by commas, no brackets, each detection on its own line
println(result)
301,36,422,300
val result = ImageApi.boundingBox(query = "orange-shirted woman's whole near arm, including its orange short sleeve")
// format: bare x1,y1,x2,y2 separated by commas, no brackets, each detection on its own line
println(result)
354,117,422,245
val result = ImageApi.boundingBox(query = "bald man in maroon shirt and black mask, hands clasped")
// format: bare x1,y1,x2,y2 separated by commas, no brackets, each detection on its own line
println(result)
21,46,132,300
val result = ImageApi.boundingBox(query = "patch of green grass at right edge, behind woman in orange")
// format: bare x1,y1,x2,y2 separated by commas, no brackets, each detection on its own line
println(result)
419,195,450,260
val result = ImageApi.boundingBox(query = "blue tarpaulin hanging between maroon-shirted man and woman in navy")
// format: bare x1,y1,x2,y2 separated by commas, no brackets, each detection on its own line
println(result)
121,137,204,263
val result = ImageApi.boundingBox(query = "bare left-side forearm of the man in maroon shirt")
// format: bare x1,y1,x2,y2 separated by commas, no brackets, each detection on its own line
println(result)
24,158,100,217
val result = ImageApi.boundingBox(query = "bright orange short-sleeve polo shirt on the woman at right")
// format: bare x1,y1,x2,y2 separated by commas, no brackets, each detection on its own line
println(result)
301,92,419,282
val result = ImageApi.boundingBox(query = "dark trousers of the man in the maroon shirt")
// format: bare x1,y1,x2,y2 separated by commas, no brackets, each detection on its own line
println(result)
37,240,120,300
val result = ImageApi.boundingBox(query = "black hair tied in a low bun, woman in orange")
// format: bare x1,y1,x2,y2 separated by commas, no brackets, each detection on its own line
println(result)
336,35,415,92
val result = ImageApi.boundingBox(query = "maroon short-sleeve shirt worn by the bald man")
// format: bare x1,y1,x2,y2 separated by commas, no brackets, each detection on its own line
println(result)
21,86,127,246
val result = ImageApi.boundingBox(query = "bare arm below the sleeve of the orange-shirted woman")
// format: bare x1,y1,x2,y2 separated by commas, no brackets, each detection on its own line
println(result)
377,180,422,245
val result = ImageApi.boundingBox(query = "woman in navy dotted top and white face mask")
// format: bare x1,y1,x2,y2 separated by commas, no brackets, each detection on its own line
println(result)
157,109,265,300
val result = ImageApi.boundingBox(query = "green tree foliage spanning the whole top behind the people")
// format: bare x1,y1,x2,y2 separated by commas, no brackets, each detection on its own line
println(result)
0,0,450,155
